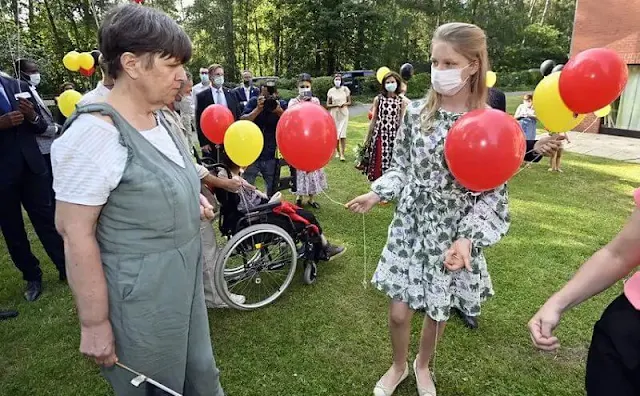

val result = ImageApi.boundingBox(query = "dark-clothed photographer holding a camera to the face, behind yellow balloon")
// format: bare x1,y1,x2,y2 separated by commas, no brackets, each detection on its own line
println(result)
242,81,287,196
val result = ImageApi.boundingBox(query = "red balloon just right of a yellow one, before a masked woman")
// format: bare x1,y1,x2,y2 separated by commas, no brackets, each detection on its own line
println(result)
276,102,338,172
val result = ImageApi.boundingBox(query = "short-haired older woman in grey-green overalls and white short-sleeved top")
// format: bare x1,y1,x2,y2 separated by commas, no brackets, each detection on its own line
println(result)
52,4,229,396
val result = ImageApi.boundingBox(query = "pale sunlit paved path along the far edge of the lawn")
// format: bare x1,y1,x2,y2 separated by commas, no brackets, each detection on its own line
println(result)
350,103,640,164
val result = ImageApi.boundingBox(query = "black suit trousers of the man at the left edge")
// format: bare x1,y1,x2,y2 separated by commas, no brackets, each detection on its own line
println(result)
0,163,64,281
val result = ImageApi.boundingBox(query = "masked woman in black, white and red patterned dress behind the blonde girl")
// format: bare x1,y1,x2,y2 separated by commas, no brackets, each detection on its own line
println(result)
364,72,405,181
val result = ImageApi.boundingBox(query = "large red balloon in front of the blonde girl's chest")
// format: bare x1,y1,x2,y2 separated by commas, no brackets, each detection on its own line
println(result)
444,109,526,192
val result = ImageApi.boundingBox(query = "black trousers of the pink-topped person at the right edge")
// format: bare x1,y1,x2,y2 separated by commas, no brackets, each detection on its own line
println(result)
585,295,640,396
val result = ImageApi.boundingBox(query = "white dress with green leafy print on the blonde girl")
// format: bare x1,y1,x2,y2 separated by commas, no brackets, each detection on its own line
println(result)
371,100,509,321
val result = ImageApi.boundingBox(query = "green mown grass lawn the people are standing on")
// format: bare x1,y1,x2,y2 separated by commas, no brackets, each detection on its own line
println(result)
0,117,640,396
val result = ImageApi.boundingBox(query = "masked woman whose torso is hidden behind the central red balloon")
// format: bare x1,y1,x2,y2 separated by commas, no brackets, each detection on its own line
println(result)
288,73,327,209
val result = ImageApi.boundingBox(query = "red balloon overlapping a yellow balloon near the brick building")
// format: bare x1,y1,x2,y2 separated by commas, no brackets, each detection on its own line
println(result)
559,48,629,114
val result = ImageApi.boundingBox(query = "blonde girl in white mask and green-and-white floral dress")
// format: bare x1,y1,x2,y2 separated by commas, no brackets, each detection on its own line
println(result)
347,23,509,396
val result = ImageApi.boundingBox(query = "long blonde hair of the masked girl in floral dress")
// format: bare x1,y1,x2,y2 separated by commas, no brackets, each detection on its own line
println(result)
422,22,489,129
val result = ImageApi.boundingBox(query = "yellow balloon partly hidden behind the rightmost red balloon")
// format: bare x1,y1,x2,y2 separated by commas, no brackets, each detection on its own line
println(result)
533,73,585,132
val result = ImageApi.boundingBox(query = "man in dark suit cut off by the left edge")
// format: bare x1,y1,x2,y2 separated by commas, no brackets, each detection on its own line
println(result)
0,72,66,301
